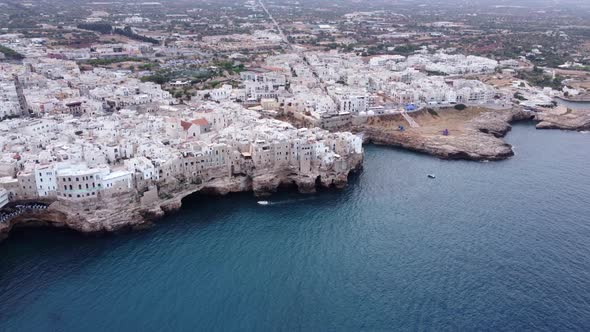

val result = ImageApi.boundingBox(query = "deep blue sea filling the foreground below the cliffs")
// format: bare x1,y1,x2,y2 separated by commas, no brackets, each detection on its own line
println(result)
0,124,590,331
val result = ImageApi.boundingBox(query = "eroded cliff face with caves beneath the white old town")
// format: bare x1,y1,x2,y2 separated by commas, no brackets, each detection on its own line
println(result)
0,154,363,241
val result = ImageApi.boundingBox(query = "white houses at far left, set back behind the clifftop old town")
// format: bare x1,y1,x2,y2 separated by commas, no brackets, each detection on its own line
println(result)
0,57,175,119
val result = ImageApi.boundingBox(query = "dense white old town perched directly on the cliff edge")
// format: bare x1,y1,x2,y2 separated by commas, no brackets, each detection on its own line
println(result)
0,103,362,204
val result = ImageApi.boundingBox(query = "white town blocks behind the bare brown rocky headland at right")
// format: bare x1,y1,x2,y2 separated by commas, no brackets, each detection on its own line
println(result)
194,52,501,129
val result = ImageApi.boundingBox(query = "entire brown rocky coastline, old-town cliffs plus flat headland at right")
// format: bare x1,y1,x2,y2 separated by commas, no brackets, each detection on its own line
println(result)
0,107,590,242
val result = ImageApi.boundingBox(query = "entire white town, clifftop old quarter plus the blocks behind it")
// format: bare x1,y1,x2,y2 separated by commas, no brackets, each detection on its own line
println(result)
0,48,506,210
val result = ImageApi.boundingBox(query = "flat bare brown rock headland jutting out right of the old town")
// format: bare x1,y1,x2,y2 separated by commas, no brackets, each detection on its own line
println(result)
347,106,590,161
